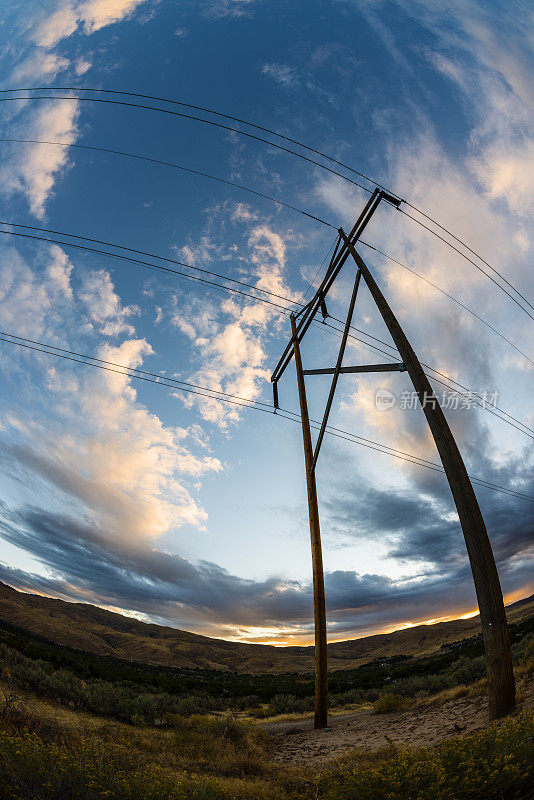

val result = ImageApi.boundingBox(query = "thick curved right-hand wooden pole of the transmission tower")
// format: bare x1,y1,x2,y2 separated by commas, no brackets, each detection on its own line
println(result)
339,228,515,719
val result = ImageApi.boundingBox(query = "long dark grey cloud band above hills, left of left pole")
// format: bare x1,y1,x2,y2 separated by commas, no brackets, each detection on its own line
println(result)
0,500,309,622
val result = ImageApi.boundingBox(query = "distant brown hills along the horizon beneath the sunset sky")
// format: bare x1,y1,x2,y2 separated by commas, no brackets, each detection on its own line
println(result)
0,583,534,673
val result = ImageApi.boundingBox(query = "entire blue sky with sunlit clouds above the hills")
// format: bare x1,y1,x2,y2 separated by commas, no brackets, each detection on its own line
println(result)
0,0,534,643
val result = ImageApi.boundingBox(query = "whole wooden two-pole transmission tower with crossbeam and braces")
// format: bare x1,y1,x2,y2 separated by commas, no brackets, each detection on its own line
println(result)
271,189,515,728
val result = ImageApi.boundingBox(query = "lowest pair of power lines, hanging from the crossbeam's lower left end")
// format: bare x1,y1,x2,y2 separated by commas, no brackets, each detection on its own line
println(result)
0,332,534,502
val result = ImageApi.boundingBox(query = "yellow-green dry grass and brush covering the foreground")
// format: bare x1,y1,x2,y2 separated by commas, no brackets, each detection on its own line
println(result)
0,671,534,800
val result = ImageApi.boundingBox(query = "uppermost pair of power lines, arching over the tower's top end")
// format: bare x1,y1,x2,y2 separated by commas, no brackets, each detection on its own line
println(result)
0,87,534,319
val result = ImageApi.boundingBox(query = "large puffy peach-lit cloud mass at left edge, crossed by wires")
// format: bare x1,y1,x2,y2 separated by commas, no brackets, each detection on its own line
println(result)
0,241,223,541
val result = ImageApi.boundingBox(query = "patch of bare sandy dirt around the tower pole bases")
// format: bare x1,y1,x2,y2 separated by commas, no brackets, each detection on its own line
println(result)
262,686,534,765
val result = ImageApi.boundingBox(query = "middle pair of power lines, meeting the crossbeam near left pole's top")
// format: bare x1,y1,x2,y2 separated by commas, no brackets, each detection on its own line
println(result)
0,221,534,438
